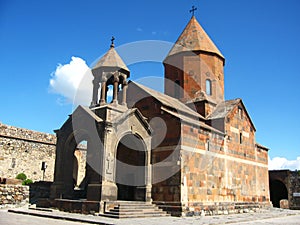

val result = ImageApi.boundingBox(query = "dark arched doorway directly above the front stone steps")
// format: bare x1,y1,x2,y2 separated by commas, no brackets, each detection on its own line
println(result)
116,134,147,201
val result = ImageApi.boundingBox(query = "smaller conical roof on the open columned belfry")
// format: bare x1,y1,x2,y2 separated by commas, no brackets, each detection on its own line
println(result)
93,44,129,72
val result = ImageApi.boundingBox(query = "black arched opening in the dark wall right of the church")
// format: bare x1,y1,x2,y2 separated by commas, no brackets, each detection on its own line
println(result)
270,180,288,208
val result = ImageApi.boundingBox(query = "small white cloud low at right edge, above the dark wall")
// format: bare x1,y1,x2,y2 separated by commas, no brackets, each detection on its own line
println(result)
269,157,300,170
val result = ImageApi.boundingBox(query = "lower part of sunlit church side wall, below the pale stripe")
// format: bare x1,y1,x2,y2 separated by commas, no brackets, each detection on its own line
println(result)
182,151,269,205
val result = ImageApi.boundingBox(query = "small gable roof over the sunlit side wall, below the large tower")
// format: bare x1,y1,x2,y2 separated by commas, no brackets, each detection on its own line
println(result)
207,98,256,130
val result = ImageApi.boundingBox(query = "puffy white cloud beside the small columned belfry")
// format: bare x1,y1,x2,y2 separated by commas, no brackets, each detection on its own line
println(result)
50,56,93,106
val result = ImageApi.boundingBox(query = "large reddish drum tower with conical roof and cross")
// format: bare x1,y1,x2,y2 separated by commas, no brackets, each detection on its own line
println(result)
164,12,225,107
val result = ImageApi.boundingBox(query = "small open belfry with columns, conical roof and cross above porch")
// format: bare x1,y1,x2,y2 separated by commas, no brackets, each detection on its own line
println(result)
91,37,130,107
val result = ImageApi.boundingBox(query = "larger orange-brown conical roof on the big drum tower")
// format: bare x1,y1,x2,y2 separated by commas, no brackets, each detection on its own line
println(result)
167,16,225,59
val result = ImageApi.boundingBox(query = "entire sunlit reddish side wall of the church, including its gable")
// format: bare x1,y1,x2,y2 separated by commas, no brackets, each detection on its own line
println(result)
181,105,269,207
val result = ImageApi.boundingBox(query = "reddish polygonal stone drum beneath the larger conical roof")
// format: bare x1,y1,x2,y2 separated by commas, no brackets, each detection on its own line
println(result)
164,52,224,102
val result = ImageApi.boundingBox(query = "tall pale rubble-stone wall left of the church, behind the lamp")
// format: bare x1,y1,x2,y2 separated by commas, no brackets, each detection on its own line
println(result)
0,123,56,181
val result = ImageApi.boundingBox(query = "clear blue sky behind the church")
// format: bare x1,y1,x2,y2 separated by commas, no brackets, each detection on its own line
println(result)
0,0,300,165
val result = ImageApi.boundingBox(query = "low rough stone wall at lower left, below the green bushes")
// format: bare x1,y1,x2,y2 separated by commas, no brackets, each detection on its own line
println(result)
0,184,29,206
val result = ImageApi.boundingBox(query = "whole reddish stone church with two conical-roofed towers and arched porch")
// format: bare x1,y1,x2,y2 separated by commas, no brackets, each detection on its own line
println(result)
51,16,270,216
